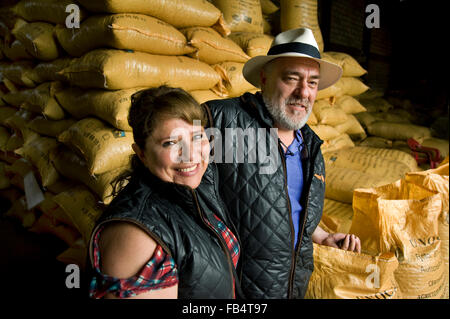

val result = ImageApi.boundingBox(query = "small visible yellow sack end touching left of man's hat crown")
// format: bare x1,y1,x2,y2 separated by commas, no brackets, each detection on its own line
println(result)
228,32,274,57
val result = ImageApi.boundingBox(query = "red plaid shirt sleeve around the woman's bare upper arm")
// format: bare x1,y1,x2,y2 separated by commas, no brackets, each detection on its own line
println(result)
89,228,178,298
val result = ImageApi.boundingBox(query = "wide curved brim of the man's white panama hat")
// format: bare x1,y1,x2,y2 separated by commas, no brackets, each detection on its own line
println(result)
242,53,342,90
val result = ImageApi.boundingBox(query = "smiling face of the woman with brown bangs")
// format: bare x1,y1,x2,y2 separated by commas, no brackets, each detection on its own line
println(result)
133,119,210,188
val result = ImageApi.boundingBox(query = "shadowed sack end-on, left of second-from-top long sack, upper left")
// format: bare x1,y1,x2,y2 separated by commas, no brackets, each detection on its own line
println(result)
12,22,60,61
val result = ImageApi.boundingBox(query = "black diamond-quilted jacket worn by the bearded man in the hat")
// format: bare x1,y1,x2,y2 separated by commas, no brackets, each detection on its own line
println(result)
204,93,325,299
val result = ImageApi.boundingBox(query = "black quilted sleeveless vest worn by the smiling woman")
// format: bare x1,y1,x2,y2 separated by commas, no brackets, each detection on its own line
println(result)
90,164,239,299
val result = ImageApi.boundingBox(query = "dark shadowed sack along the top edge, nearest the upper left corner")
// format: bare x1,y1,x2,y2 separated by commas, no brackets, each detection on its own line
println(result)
13,0,86,24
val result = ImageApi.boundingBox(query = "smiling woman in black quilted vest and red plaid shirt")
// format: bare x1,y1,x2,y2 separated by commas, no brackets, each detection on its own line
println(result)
89,86,240,298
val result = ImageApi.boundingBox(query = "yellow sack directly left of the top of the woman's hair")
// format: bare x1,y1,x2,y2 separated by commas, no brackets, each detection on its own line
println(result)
55,87,144,131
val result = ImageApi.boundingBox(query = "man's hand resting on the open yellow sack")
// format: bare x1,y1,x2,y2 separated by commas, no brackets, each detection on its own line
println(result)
312,226,361,253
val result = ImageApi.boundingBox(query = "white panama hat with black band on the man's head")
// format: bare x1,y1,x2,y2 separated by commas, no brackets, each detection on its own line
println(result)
242,28,342,90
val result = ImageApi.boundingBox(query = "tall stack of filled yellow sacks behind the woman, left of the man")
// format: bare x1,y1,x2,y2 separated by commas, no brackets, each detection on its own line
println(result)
0,0,261,266
